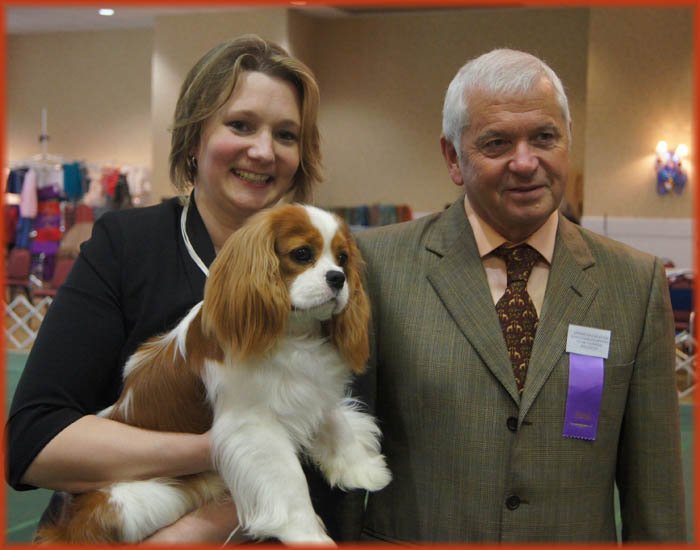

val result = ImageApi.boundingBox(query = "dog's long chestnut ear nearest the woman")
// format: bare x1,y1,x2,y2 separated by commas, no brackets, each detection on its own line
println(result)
202,210,291,359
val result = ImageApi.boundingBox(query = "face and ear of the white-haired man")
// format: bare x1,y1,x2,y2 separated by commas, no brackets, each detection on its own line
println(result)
442,80,569,242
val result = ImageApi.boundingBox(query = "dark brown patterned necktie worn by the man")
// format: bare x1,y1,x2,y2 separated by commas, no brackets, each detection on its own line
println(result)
493,244,540,392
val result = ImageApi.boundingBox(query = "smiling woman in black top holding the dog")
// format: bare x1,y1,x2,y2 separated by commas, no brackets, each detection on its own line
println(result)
7,35,320,542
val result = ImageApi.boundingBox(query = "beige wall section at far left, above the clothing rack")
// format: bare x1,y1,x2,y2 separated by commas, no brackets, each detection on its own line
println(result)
6,30,153,166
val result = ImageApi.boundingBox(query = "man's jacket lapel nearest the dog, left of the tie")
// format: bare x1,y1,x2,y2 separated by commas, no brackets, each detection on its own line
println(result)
426,199,519,402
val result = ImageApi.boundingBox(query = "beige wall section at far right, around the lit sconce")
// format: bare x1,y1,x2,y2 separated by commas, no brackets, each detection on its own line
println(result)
584,8,696,218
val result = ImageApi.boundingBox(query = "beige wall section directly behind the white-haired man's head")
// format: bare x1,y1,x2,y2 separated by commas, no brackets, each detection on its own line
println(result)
306,9,588,215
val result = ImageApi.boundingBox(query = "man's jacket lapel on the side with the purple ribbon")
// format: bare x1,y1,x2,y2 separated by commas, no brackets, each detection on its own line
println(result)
520,216,598,420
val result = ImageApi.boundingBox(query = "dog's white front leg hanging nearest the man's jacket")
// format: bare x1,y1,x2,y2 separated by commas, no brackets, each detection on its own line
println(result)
309,399,391,491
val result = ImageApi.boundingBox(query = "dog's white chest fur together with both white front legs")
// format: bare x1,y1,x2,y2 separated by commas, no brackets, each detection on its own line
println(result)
204,337,391,543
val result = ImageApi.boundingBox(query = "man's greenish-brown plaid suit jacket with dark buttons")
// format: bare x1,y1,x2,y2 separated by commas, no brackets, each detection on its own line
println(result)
342,199,685,542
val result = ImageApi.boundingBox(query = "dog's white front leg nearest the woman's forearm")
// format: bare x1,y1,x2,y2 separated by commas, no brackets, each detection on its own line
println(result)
211,411,333,544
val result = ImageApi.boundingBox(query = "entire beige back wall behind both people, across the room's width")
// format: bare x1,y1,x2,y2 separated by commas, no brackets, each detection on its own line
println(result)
7,7,693,222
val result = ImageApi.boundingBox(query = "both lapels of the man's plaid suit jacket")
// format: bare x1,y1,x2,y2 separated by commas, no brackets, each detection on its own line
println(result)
426,207,598,419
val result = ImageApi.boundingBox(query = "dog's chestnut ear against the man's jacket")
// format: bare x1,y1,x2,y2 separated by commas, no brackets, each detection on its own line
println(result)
330,224,370,374
